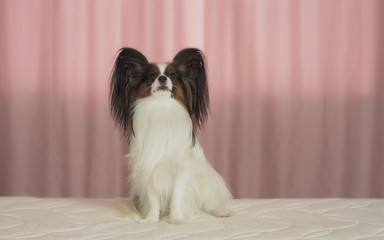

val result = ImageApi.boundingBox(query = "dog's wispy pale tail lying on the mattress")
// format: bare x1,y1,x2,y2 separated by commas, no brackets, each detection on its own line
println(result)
109,198,142,222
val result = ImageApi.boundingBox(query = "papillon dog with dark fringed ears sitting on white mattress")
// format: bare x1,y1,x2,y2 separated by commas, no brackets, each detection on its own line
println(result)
110,48,232,223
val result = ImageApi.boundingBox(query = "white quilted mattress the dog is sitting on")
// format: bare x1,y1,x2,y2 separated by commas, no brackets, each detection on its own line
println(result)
0,197,384,240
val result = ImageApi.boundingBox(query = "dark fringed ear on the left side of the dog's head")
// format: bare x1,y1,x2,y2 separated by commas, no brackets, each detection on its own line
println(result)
110,48,149,137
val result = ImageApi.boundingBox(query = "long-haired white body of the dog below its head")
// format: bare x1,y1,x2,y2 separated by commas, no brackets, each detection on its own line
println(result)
129,86,231,223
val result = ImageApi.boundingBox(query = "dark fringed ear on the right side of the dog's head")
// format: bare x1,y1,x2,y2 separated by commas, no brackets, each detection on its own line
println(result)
172,48,209,132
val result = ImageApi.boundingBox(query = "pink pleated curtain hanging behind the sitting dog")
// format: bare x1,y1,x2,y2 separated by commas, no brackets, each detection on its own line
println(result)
0,0,384,198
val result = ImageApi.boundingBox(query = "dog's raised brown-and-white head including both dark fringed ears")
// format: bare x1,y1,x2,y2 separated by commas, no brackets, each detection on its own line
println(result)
110,48,209,137
